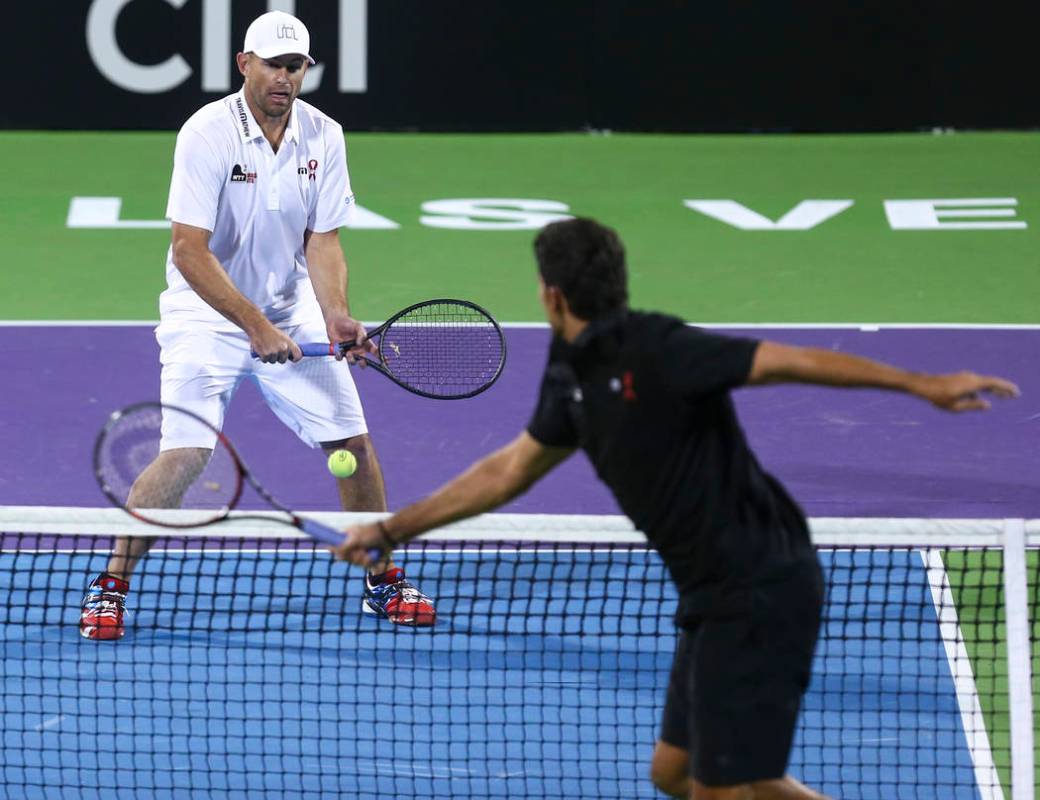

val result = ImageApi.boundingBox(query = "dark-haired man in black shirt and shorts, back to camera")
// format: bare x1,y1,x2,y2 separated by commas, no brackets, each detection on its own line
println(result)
337,218,1017,800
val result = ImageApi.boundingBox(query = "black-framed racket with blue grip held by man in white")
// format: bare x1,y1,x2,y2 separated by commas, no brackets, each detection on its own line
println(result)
260,300,505,399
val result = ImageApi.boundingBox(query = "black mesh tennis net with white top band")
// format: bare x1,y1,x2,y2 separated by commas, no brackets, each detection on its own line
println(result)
0,508,1040,800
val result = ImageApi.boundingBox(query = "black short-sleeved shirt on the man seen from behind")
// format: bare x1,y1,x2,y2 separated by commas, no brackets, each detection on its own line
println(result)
527,311,815,625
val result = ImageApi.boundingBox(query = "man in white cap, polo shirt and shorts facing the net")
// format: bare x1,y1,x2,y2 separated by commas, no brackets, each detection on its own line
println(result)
80,11,436,639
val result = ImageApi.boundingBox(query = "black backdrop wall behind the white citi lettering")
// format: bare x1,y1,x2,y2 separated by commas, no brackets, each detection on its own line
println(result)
10,0,1040,131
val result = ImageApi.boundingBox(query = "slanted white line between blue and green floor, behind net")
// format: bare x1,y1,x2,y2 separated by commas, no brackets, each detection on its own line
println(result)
918,548,1005,800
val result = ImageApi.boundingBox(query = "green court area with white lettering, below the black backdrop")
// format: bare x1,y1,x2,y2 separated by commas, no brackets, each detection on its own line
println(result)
0,131,1040,322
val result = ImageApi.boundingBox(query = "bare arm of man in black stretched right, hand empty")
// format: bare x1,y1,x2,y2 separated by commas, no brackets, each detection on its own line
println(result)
747,341,1018,411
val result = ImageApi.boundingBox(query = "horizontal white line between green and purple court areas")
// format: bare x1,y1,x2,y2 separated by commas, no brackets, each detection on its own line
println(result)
0,319,1040,332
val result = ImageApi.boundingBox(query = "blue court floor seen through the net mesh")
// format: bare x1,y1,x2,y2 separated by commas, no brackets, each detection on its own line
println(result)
0,544,999,799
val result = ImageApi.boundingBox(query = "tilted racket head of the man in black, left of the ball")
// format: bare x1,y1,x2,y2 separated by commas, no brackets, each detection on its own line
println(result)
94,402,245,527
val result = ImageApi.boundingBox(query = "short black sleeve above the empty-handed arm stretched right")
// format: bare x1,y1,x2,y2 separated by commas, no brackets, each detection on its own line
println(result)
659,321,758,399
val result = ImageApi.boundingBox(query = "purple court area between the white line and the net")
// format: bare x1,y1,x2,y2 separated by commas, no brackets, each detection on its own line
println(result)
0,325,1040,518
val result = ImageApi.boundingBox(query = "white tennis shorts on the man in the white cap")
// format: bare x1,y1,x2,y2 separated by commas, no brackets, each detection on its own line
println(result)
155,321,368,450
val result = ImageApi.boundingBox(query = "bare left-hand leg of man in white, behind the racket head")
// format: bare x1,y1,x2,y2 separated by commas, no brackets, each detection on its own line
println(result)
106,447,212,580
